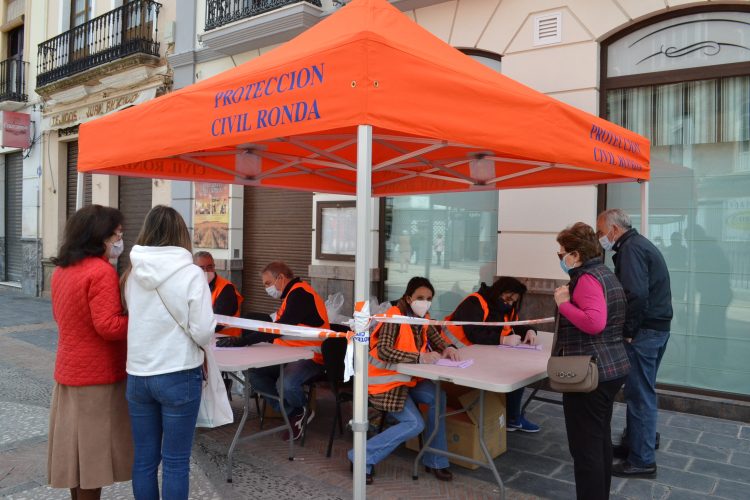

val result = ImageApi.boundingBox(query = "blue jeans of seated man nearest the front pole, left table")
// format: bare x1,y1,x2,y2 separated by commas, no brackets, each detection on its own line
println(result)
249,359,323,416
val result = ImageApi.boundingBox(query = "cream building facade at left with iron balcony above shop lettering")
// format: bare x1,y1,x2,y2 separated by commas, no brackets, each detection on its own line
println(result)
33,0,176,292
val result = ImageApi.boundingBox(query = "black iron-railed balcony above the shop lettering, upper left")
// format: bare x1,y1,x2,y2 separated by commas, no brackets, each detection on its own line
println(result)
36,0,161,89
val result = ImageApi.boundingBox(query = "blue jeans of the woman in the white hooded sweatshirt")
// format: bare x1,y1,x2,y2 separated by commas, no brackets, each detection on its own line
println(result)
127,366,203,500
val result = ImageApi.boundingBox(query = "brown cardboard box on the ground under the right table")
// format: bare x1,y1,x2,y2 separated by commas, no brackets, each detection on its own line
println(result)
406,384,507,470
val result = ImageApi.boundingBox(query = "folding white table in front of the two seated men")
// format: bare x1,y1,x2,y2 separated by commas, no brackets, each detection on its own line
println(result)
214,343,313,483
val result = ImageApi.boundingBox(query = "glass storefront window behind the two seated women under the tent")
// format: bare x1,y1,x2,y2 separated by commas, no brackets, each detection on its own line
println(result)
385,191,498,319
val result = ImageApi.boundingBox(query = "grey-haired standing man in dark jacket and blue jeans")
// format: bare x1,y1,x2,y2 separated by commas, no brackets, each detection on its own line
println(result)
596,209,672,477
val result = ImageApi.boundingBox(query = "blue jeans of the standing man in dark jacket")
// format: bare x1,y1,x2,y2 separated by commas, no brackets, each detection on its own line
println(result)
623,329,669,467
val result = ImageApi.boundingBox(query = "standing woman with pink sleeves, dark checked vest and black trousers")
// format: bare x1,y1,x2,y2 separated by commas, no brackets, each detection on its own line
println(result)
553,222,630,500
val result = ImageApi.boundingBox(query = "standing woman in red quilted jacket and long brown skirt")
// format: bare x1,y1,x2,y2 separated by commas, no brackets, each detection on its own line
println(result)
47,205,133,500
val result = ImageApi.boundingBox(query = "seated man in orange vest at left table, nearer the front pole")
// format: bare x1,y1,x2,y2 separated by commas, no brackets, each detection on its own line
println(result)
242,262,330,440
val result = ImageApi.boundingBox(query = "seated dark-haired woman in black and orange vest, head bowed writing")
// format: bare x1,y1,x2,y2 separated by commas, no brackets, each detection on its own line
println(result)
443,276,539,432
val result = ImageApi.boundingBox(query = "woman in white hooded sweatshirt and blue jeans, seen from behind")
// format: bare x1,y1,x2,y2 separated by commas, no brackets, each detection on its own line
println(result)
124,205,216,500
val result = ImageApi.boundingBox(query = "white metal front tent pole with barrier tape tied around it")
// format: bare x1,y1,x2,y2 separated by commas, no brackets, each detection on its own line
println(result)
352,125,373,500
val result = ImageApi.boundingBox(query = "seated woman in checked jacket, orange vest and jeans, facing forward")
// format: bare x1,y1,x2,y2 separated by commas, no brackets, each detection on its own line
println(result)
349,277,458,484
